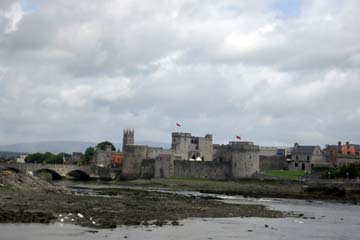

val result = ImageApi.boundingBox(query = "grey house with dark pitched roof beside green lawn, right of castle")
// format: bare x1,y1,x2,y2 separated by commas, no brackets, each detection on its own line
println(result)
289,143,326,171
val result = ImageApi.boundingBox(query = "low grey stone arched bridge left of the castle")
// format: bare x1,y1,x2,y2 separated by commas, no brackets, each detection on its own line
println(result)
0,163,114,180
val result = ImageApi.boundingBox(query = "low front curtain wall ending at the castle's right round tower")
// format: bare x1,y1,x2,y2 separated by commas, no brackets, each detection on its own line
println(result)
174,161,231,180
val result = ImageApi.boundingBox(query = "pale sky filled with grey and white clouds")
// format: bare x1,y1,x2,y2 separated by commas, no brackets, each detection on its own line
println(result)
0,0,360,146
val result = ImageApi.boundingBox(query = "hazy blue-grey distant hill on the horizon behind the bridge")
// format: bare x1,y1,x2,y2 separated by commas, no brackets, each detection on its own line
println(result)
0,141,171,153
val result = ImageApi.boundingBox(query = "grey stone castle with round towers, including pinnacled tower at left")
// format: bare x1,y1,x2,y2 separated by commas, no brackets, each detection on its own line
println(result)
122,129,260,179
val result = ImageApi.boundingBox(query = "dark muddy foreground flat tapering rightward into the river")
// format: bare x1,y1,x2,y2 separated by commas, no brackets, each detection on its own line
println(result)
0,189,284,228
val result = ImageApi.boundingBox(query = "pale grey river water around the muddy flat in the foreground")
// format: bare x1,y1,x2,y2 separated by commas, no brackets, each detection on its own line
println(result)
0,183,360,240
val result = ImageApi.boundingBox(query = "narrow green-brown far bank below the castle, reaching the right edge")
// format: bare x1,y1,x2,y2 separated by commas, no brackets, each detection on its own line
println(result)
109,178,360,204
